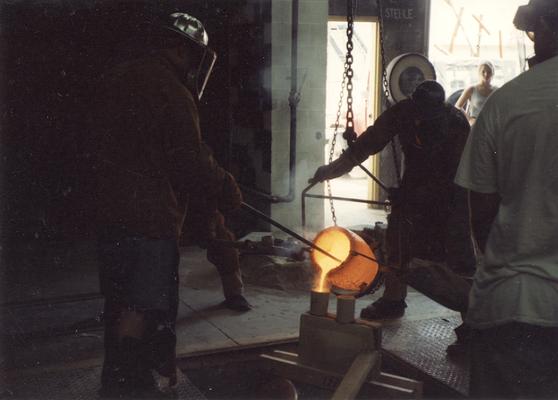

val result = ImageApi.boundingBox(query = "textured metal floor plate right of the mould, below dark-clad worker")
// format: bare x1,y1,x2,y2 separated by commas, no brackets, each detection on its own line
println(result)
382,316,469,396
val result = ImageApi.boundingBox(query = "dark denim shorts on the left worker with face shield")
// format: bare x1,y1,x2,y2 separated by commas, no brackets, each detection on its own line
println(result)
98,235,179,313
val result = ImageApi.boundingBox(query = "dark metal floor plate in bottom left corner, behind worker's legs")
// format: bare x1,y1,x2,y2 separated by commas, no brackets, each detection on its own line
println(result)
4,366,205,400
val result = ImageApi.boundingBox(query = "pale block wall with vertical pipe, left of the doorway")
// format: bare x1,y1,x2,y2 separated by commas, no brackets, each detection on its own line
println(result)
271,0,328,234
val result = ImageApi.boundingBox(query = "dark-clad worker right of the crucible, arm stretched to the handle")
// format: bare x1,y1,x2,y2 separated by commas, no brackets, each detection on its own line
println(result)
310,80,469,319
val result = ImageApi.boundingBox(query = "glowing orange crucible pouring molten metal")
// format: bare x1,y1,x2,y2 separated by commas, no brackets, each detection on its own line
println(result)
311,226,378,292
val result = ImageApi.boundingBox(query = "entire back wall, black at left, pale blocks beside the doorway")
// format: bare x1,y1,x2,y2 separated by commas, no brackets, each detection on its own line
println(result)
0,0,434,302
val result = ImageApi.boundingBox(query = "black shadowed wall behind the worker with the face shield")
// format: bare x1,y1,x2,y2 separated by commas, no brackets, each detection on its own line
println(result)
0,0,271,295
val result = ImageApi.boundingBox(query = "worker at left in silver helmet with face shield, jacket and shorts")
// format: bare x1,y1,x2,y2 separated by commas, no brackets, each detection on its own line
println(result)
90,13,240,397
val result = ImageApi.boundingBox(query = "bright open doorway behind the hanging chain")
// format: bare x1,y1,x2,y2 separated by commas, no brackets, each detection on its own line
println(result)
324,18,385,227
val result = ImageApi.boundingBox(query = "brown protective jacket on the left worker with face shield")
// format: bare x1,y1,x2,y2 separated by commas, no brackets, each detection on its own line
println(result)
90,51,236,238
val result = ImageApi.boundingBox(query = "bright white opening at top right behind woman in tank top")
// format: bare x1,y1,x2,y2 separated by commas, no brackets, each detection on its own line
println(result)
429,0,533,97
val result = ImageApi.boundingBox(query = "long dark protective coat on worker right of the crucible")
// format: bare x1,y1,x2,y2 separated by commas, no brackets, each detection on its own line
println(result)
347,100,470,263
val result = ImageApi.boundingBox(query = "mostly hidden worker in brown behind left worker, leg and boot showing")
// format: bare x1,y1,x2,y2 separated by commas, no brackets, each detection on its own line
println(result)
181,147,252,312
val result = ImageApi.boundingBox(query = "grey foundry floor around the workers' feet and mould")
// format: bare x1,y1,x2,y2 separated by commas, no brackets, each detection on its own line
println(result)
0,241,466,399
